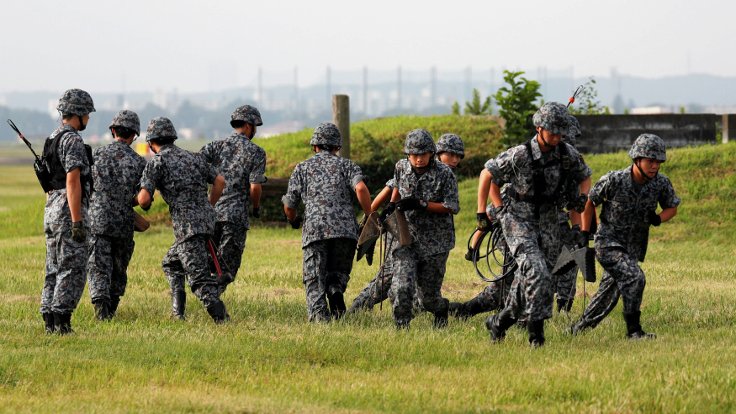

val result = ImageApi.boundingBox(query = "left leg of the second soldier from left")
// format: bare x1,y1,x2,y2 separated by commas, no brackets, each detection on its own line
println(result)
87,234,117,320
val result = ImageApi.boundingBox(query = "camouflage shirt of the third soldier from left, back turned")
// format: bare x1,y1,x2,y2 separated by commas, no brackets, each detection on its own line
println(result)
141,144,217,241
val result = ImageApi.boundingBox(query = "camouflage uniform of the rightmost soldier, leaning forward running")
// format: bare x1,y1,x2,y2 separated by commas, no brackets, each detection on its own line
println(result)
579,166,680,330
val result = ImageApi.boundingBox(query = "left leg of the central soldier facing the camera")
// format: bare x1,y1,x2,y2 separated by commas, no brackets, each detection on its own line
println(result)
390,246,418,329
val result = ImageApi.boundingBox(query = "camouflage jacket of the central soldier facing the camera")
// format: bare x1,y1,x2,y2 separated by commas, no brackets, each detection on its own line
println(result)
394,158,460,258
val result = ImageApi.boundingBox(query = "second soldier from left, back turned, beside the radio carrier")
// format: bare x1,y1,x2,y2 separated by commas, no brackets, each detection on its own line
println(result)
87,109,146,320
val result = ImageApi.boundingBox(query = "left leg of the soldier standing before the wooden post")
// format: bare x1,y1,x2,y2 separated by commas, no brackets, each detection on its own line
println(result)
302,240,330,322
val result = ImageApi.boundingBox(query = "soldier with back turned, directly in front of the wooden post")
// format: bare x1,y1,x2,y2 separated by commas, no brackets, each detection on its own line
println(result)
282,123,371,322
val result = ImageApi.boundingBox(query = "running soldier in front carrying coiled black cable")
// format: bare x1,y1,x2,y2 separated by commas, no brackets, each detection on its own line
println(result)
478,102,591,346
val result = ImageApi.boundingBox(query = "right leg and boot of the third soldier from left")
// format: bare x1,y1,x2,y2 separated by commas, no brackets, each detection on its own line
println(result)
179,235,230,323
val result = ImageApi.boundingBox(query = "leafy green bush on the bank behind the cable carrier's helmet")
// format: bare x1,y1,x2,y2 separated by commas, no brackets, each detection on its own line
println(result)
494,70,542,146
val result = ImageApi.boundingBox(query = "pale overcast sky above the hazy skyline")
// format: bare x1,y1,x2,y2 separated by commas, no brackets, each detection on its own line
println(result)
0,0,736,92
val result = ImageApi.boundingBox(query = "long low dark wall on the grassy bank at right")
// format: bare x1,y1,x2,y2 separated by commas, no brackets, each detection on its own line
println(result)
577,114,720,153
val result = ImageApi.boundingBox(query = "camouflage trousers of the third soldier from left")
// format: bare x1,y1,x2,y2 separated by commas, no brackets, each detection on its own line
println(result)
161,234,220,308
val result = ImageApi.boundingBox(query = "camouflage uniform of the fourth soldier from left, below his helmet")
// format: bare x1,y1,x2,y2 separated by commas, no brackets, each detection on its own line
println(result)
201,128,266,290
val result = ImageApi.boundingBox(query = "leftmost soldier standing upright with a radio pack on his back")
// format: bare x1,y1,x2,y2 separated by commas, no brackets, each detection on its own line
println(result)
41,89,95,335
